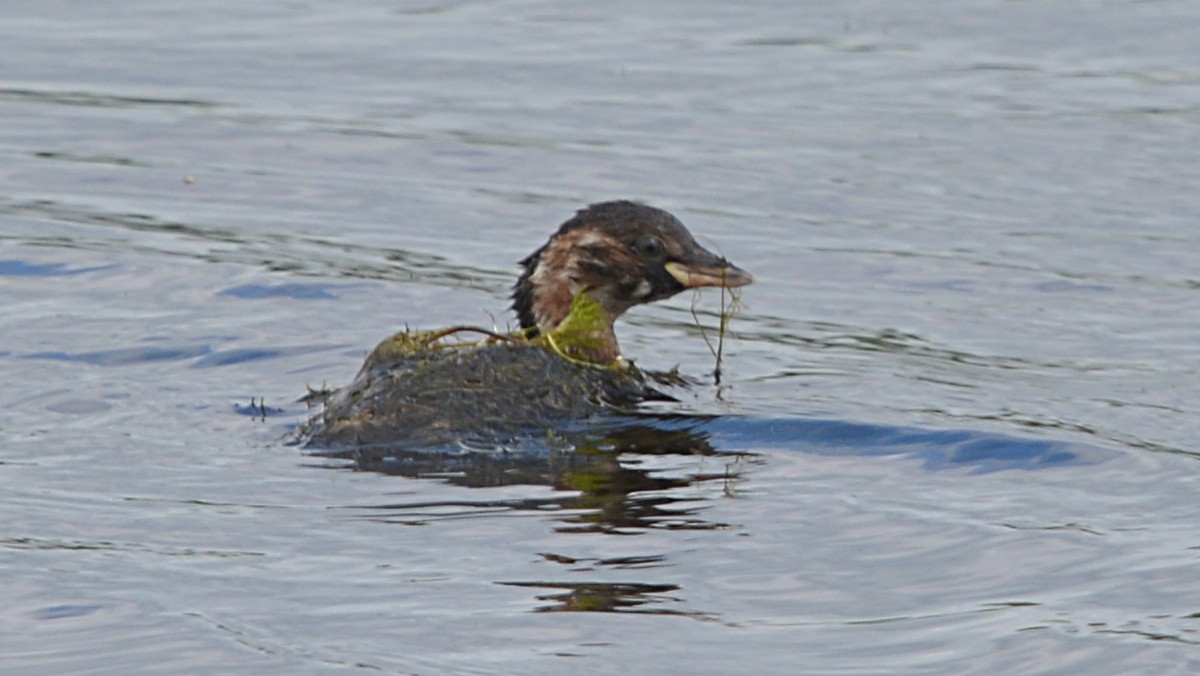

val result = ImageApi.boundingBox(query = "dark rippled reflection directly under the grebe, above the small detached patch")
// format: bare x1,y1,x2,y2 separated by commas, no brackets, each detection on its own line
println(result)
319,418,757,533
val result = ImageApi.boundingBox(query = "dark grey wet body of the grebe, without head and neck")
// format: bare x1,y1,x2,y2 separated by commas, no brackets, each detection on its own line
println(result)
298,331,665,448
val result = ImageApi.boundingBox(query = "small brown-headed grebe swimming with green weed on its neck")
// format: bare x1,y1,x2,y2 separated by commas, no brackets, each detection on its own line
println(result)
305,201,754,448
